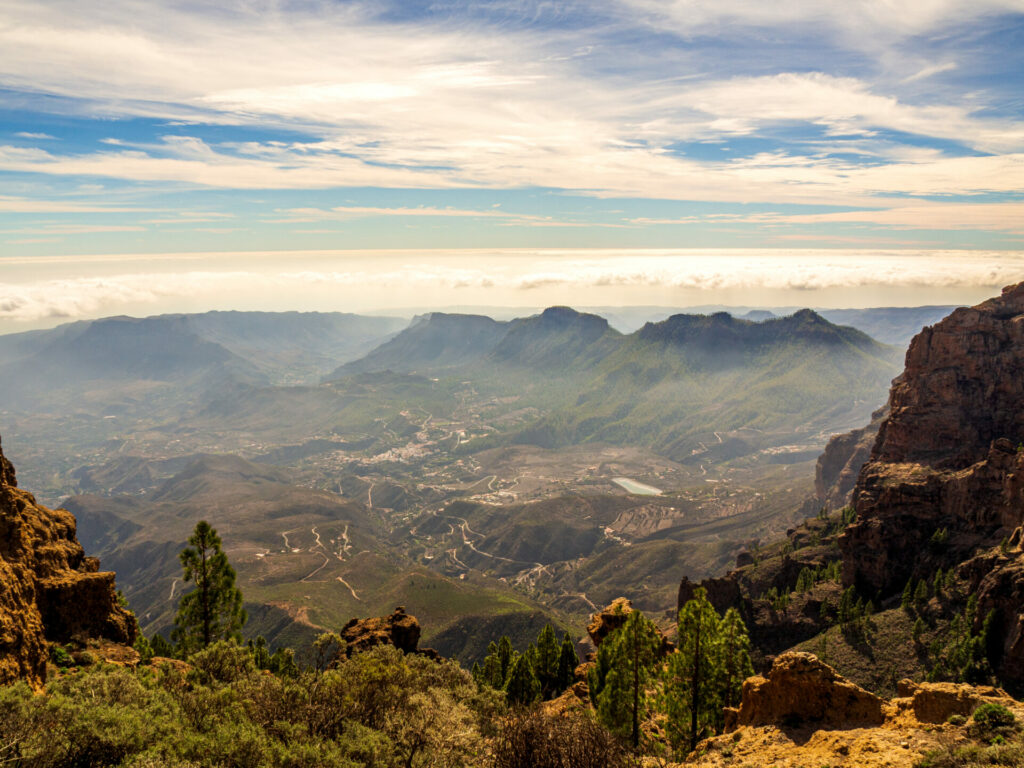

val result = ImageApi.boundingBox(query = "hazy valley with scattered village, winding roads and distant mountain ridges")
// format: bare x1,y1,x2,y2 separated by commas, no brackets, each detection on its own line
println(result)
0,307,933,662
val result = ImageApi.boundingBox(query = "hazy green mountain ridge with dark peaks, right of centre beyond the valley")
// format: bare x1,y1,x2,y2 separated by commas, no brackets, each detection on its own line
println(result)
330,307,900,461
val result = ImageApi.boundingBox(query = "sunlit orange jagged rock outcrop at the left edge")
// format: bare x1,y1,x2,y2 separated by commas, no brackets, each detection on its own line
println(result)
0,436,137,686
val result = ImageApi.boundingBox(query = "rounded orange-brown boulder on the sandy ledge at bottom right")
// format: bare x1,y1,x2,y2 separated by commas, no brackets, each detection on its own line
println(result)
729,653,886,728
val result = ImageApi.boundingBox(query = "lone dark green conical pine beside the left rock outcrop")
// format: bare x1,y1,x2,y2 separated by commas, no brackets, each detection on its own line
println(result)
171,520,247,655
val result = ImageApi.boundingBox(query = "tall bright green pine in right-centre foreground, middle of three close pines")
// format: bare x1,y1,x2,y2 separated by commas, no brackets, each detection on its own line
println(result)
664,588,724,750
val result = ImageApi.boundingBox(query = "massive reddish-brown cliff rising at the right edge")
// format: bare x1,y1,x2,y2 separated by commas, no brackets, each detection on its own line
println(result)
840,284,1024,686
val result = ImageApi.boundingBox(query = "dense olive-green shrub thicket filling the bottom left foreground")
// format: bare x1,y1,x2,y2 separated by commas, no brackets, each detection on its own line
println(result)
0,643,499,768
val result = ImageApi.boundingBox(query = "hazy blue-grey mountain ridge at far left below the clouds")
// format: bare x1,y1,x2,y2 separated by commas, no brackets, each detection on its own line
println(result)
0,312,404,409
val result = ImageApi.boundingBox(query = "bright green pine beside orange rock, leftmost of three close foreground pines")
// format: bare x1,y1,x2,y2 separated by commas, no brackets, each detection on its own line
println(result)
589,610,662,746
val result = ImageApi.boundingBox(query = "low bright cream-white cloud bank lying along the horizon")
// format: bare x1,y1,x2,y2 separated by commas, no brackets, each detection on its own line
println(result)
0,248,1024,328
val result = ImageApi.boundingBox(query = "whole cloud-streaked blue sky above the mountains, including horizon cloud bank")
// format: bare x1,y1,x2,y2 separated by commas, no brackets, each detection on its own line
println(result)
0,0,1024,333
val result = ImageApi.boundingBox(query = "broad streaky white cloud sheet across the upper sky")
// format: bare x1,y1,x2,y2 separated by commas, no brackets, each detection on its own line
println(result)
0,0,1024,226
